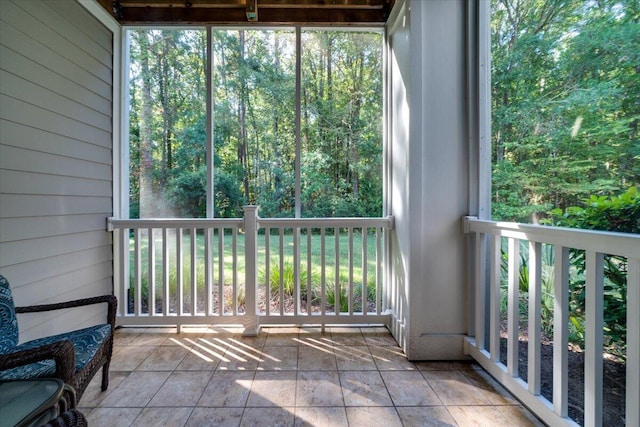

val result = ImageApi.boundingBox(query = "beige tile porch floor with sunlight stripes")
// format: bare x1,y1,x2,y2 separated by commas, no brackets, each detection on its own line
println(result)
79,328,542,427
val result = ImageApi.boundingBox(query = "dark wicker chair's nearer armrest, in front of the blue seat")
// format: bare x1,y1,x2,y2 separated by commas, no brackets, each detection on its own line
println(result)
0,340,76,383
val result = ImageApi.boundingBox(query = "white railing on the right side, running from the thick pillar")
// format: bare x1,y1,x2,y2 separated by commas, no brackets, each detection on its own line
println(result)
464,217,640,426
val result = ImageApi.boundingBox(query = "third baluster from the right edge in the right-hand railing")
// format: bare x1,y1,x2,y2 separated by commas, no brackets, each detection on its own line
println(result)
553,245,569,417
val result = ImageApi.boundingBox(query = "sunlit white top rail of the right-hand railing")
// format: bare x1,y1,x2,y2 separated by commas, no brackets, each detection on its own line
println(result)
464,217,640,258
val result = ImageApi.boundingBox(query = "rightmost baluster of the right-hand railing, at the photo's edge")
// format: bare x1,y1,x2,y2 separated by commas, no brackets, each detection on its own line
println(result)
625,257,640,426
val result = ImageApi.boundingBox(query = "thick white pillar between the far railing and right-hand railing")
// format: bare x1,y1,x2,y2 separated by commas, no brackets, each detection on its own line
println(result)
388,0,470,360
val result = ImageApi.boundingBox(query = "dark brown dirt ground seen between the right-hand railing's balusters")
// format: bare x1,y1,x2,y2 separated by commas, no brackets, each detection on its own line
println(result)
501,339,626,426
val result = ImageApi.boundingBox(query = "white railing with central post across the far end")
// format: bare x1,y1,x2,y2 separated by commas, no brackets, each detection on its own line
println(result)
108,206,393,335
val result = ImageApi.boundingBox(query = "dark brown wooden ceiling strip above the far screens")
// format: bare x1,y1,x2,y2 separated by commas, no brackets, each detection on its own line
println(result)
98,0,396,26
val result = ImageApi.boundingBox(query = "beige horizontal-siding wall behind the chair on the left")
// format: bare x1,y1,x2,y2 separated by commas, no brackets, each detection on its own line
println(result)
0,0,113,341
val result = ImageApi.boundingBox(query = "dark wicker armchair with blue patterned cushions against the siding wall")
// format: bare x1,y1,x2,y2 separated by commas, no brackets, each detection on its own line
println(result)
0,275,117,401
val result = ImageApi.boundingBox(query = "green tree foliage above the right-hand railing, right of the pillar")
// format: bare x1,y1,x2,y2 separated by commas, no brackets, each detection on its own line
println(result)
491,0,640,222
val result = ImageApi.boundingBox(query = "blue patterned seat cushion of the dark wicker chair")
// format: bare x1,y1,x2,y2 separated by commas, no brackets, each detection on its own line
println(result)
0,325,111,380
